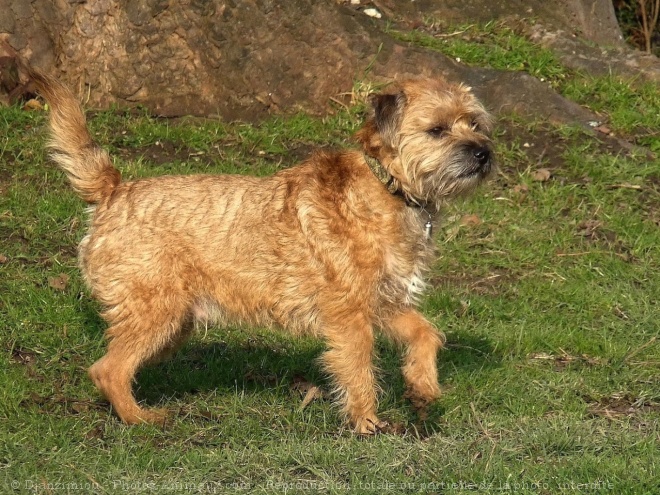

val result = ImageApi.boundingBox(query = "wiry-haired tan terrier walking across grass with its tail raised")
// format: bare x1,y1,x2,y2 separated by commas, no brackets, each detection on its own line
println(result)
33,73,493,434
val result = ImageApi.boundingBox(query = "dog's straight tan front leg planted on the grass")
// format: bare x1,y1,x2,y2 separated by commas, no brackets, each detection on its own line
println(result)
321,314,386,434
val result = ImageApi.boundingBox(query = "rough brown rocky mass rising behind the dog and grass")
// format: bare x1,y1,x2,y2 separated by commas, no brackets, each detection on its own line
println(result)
0,0,656,121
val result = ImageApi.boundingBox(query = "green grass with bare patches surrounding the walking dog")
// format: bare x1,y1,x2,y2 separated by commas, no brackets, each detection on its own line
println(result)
0,21,660,494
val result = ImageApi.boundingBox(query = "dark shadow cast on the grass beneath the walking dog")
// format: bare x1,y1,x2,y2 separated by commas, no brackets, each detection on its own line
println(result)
129,326,501,437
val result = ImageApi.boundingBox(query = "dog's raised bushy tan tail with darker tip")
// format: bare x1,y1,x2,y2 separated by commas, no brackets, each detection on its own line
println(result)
29,69,121,203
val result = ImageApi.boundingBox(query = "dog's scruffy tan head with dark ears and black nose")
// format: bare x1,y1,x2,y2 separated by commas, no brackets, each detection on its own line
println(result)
357,79,494,206
